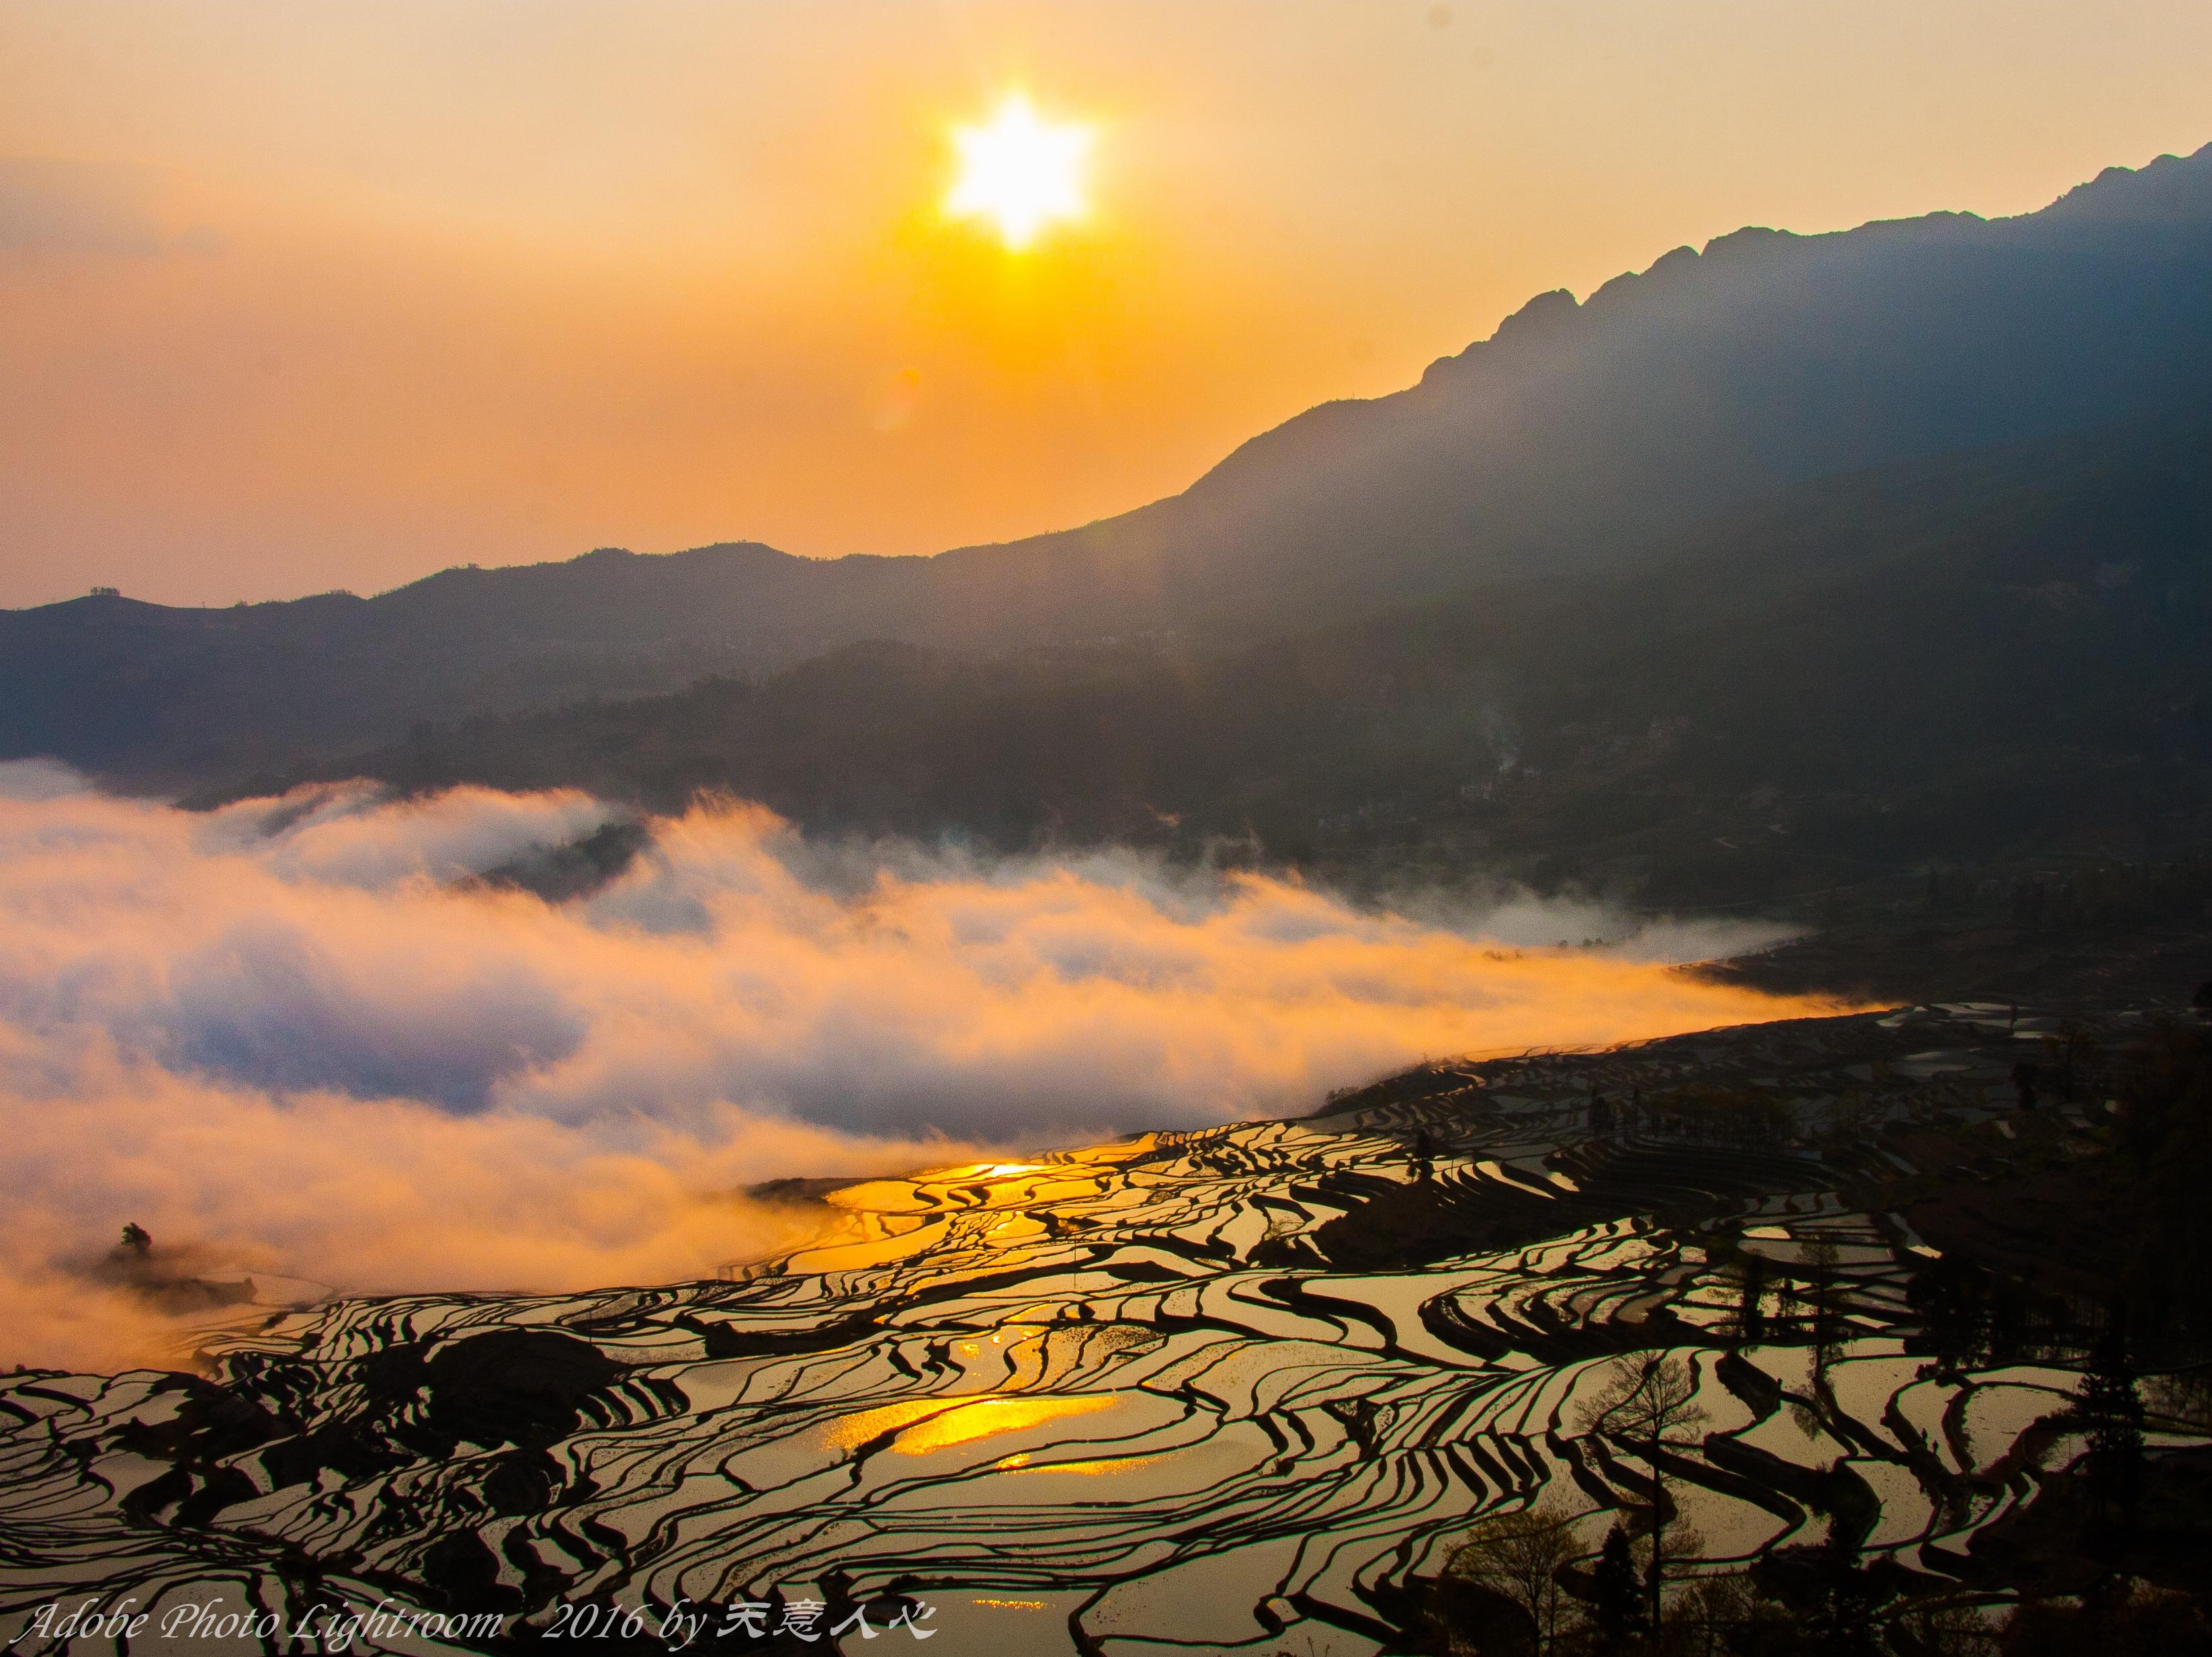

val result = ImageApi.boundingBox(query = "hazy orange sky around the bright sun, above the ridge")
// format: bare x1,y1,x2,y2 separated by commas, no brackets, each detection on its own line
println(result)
0,0,2212,604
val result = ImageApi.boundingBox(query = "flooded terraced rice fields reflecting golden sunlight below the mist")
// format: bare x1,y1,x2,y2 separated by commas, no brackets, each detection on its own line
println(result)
0,1009,2194,1657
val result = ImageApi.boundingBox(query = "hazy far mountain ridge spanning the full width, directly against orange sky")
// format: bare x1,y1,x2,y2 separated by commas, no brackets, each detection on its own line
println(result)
0,148,2212,781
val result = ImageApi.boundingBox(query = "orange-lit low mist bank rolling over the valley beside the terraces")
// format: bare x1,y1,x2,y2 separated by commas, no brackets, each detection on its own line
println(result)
0,763,1827,1367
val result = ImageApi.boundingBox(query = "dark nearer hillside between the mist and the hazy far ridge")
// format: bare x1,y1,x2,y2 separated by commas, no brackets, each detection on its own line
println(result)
261,400,2212,905
